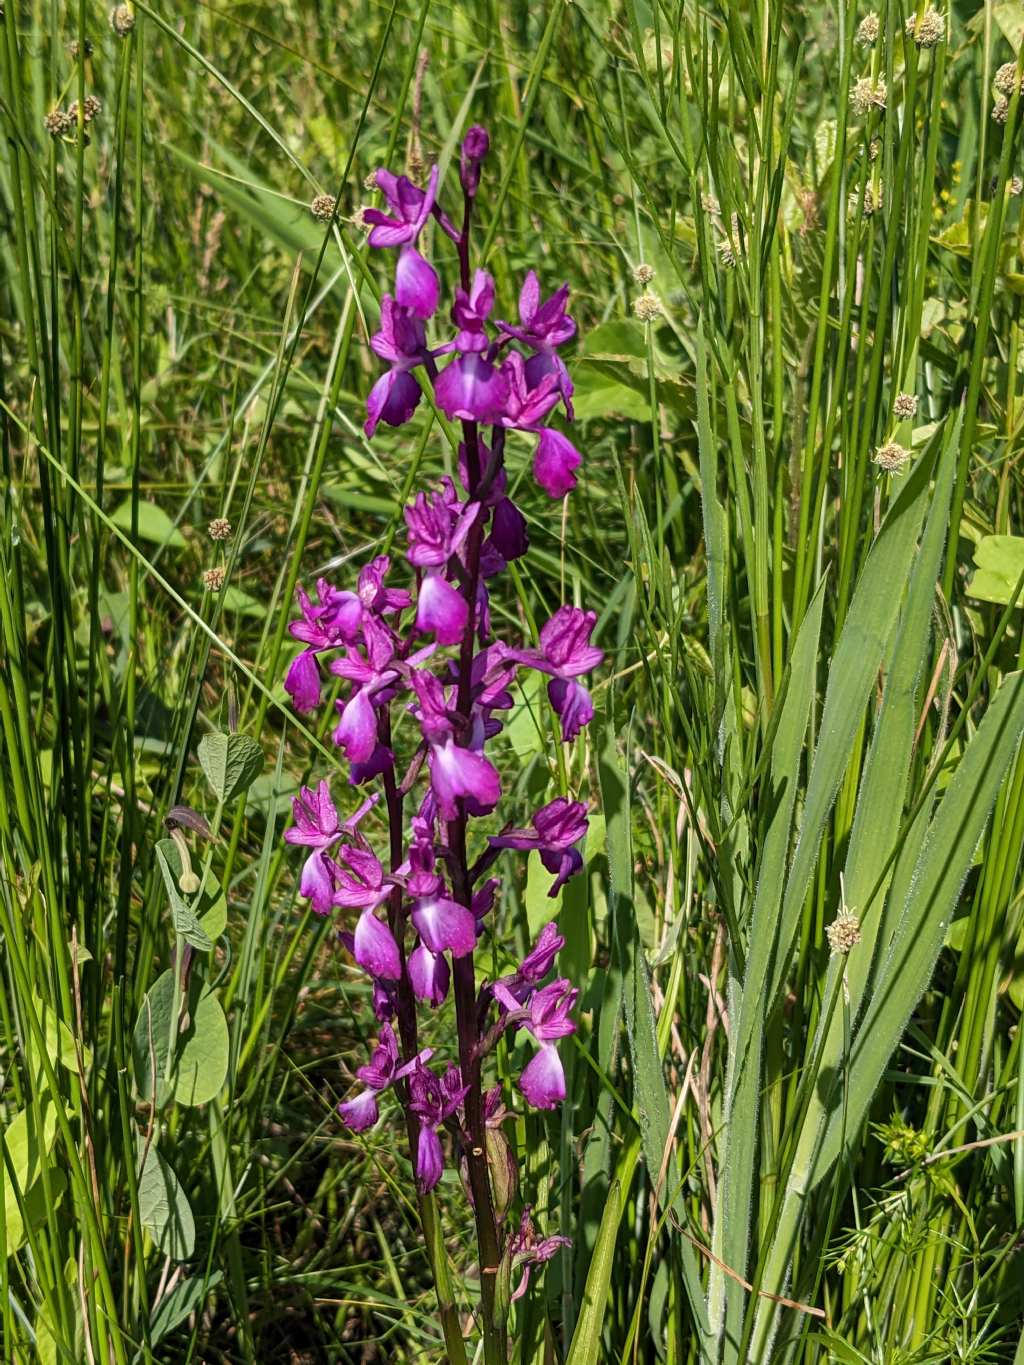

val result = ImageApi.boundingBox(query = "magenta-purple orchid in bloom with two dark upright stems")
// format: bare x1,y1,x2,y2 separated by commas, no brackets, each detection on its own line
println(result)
285,128,603,1365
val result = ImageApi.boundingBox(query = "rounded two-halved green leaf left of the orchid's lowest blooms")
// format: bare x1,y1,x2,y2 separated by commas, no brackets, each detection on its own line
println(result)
131,969,228,1108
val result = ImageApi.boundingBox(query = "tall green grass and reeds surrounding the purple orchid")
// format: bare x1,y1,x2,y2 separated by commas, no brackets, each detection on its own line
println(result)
0,0,1024,1365
